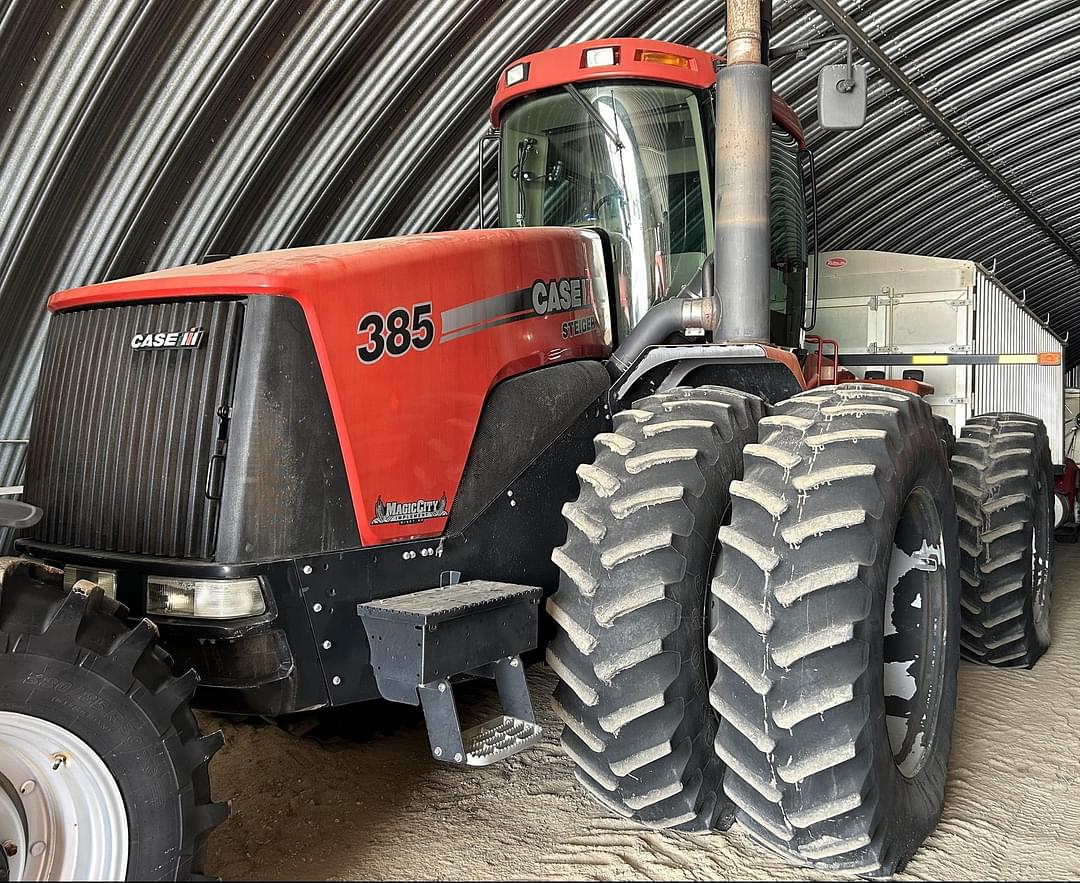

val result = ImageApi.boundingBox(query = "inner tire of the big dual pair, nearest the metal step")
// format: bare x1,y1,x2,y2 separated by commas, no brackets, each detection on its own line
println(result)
548,386,762,831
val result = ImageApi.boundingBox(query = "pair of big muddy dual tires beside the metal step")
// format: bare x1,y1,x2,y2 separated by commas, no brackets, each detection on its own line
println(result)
549,385,960,875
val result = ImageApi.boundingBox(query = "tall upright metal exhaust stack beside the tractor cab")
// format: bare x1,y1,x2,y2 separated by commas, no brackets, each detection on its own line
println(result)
714,0,772,342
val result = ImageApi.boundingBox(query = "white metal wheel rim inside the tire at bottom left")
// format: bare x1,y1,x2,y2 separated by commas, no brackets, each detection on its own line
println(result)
0,711,129,880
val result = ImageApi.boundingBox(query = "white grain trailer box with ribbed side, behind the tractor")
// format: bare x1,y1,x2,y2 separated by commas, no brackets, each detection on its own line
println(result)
811,250,1066,464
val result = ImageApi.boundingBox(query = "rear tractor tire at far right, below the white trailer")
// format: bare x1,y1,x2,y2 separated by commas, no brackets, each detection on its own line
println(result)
953,413,1054,668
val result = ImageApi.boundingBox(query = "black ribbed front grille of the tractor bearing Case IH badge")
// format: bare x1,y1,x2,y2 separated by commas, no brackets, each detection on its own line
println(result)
23,301,243,559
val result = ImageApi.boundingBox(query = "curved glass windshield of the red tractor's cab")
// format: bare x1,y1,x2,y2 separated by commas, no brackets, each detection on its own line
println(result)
499,83,713,336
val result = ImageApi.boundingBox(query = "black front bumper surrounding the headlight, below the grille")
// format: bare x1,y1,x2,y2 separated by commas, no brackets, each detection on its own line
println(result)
16,540,328,716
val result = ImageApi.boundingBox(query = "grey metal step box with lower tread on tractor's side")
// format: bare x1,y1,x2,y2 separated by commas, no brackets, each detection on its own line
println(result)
357,580,542,766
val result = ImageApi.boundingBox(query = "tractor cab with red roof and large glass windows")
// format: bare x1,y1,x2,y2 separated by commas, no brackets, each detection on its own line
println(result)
491,39,807,348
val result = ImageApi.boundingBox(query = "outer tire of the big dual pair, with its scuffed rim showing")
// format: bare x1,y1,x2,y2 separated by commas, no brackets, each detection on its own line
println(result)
710,384,960,877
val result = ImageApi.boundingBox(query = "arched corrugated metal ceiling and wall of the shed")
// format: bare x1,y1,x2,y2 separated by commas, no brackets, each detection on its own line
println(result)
0,0,1080,486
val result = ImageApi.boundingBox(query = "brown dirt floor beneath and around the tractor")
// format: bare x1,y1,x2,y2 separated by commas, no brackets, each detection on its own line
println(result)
204,545,1080,880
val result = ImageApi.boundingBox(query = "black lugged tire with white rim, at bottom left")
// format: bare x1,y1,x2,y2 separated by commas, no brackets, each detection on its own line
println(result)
0,558,228,880
